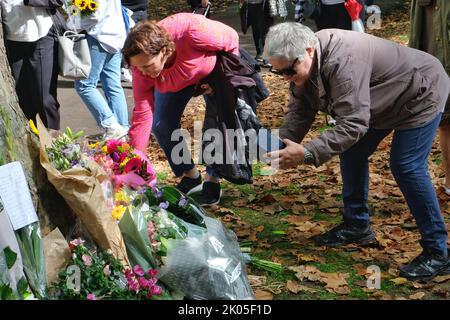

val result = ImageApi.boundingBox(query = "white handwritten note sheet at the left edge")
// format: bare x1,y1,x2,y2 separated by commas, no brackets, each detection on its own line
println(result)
0,162,38,230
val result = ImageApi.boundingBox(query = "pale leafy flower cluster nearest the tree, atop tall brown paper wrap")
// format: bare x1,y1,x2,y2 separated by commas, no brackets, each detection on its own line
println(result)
46,127,84,171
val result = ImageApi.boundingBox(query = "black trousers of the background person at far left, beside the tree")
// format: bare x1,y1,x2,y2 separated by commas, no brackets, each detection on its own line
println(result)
6,27,60,130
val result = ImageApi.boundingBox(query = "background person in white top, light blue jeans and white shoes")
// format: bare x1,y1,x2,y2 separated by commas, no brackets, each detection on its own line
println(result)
75,0,129,139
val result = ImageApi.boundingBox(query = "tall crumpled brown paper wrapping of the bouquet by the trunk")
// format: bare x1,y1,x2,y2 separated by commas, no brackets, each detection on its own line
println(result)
37,118,128,264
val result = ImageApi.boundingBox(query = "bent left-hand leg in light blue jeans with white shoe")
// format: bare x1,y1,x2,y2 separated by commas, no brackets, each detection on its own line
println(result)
75,35,128,139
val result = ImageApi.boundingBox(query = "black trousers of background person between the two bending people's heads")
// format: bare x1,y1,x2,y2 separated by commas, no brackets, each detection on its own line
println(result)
247,1,273,56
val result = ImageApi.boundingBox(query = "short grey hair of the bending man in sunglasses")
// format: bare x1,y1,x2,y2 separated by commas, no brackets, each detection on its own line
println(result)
264,22,319,61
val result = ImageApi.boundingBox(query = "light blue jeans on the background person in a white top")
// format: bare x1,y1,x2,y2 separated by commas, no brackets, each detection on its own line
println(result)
75,35,129,128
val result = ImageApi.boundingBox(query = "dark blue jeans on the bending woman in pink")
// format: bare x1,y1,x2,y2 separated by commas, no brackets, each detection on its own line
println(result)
152,85,218,177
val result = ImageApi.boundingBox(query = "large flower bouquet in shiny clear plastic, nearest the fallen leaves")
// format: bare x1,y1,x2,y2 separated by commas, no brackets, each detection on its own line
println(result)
119,187,253,300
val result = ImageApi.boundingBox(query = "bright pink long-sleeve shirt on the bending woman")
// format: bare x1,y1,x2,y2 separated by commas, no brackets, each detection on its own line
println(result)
129,13,239,151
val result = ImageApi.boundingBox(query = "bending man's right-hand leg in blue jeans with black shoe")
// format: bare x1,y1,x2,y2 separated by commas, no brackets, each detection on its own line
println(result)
390,114,450,281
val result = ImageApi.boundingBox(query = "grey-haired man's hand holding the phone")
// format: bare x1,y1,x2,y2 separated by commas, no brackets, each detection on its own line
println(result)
265,139,305,169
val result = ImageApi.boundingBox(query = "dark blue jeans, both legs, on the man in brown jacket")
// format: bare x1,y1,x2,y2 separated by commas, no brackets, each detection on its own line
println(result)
340,115,447,255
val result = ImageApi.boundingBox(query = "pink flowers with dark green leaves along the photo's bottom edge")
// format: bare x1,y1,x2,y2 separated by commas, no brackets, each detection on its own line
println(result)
52,239,169,300
